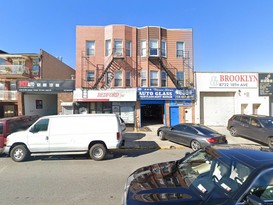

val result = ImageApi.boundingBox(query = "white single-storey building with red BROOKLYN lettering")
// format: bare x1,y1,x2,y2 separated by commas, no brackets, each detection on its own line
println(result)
195,72,273,126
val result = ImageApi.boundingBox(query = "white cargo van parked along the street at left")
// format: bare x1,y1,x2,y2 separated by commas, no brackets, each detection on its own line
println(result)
4,114,124,162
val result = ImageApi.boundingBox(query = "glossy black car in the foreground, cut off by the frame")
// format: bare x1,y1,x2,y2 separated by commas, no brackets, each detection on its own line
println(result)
122,145,273,205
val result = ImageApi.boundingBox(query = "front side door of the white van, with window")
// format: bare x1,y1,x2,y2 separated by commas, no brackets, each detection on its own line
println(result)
28,118,49,152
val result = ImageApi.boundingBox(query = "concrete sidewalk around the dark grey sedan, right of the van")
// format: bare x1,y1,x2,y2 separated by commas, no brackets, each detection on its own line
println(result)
123,124,259,150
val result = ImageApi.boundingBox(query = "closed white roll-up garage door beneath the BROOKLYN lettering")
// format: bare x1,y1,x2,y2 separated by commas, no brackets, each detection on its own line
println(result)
200,92,235,126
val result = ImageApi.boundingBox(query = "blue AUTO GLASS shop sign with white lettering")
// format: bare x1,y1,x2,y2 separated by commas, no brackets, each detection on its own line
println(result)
137,88,195,100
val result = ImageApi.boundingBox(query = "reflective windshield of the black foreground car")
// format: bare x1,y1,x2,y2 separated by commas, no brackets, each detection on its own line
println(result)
178,147,252,197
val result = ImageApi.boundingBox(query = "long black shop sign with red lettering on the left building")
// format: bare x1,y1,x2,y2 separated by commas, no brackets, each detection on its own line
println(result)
16,80,75,93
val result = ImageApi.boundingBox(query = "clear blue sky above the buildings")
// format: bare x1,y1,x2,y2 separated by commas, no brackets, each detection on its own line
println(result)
0,0,273,72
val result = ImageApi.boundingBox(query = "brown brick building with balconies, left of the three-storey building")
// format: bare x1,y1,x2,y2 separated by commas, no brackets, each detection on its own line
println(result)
0,50,75,118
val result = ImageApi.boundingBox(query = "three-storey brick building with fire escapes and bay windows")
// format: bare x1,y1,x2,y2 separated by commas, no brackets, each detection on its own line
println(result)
74,25,195,128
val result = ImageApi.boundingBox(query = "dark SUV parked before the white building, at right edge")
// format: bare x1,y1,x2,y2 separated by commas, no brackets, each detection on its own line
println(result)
227,115,273,148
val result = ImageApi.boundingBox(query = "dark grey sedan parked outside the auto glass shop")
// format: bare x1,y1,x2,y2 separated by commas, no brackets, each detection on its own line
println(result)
157,123,227,151
